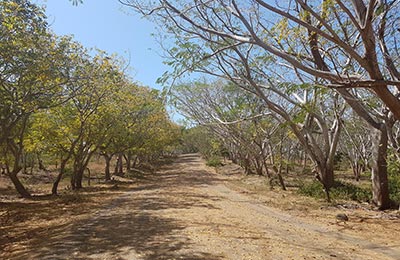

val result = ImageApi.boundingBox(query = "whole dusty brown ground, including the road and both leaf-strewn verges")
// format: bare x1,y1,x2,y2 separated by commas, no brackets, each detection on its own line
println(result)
0,155,400,260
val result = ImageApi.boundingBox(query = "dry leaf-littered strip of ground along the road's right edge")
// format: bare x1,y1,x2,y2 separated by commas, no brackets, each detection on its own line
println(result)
217,162,400,245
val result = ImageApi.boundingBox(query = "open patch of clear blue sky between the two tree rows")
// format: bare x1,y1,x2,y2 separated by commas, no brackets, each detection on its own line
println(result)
36,0,168,89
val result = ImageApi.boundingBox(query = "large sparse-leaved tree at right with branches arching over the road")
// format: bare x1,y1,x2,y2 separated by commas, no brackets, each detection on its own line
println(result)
123,0,400,209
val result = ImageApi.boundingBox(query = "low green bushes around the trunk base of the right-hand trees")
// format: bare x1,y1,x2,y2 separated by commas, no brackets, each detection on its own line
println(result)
298,181,372,202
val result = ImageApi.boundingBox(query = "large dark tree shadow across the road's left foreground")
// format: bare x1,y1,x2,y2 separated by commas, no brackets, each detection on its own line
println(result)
10,196,225,260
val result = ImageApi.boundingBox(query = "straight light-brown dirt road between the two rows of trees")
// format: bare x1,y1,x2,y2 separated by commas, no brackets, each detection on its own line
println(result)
7,155,400,260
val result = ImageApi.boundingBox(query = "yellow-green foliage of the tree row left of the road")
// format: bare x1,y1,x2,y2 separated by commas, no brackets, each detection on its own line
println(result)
0,0,185,195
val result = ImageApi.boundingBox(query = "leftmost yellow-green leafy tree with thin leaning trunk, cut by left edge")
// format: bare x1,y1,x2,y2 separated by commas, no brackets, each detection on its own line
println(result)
0,0,77,197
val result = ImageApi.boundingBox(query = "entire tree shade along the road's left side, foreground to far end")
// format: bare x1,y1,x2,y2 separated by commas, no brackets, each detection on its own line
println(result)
11,155,222,260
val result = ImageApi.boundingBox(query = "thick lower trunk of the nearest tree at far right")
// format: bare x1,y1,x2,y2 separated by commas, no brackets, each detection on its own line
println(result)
371,124,391,210
